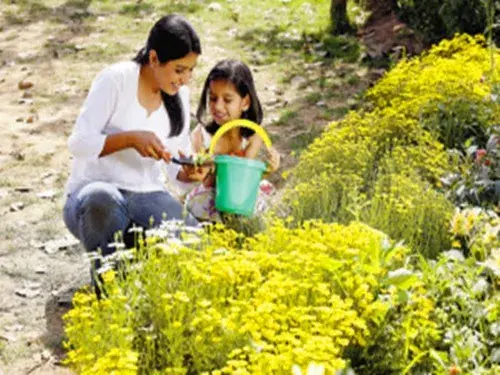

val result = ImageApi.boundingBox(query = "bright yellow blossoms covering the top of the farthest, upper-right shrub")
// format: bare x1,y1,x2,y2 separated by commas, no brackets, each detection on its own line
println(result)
366,34,500,121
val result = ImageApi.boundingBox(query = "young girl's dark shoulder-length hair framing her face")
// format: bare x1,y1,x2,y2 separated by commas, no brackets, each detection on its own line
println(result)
196,60,263,138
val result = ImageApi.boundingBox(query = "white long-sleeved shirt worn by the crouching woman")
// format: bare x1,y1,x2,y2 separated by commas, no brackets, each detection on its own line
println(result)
66,61,191,193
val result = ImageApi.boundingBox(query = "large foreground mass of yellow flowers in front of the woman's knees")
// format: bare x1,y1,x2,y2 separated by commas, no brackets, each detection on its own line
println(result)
66,221,407,374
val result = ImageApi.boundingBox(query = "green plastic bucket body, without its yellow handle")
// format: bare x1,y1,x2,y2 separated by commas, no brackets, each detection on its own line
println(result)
215,155,266,216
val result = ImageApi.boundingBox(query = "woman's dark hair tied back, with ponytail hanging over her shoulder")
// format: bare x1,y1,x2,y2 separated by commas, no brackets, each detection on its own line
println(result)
133,14,201,137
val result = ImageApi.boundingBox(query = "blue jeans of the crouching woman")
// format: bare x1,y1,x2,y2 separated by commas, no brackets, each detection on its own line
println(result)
63,182,198,255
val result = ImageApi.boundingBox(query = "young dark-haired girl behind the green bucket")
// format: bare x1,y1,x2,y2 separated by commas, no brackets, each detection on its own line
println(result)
186,60,279,222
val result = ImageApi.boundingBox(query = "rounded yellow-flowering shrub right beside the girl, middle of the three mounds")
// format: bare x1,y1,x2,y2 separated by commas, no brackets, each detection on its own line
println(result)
284,109,453,255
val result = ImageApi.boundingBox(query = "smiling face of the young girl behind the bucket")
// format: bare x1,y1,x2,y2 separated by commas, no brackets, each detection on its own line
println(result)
208,80,250,125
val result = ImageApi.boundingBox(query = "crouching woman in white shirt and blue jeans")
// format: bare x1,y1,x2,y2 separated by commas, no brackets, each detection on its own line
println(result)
64,15,201,276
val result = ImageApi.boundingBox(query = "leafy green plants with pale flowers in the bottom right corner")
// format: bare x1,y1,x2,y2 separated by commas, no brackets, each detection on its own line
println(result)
348,208,500,375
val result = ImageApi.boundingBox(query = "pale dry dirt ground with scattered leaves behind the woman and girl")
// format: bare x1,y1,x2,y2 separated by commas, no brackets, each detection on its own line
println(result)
0,4,376,375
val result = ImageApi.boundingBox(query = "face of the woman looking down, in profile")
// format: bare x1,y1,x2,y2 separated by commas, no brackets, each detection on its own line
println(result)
149,50,198,95
